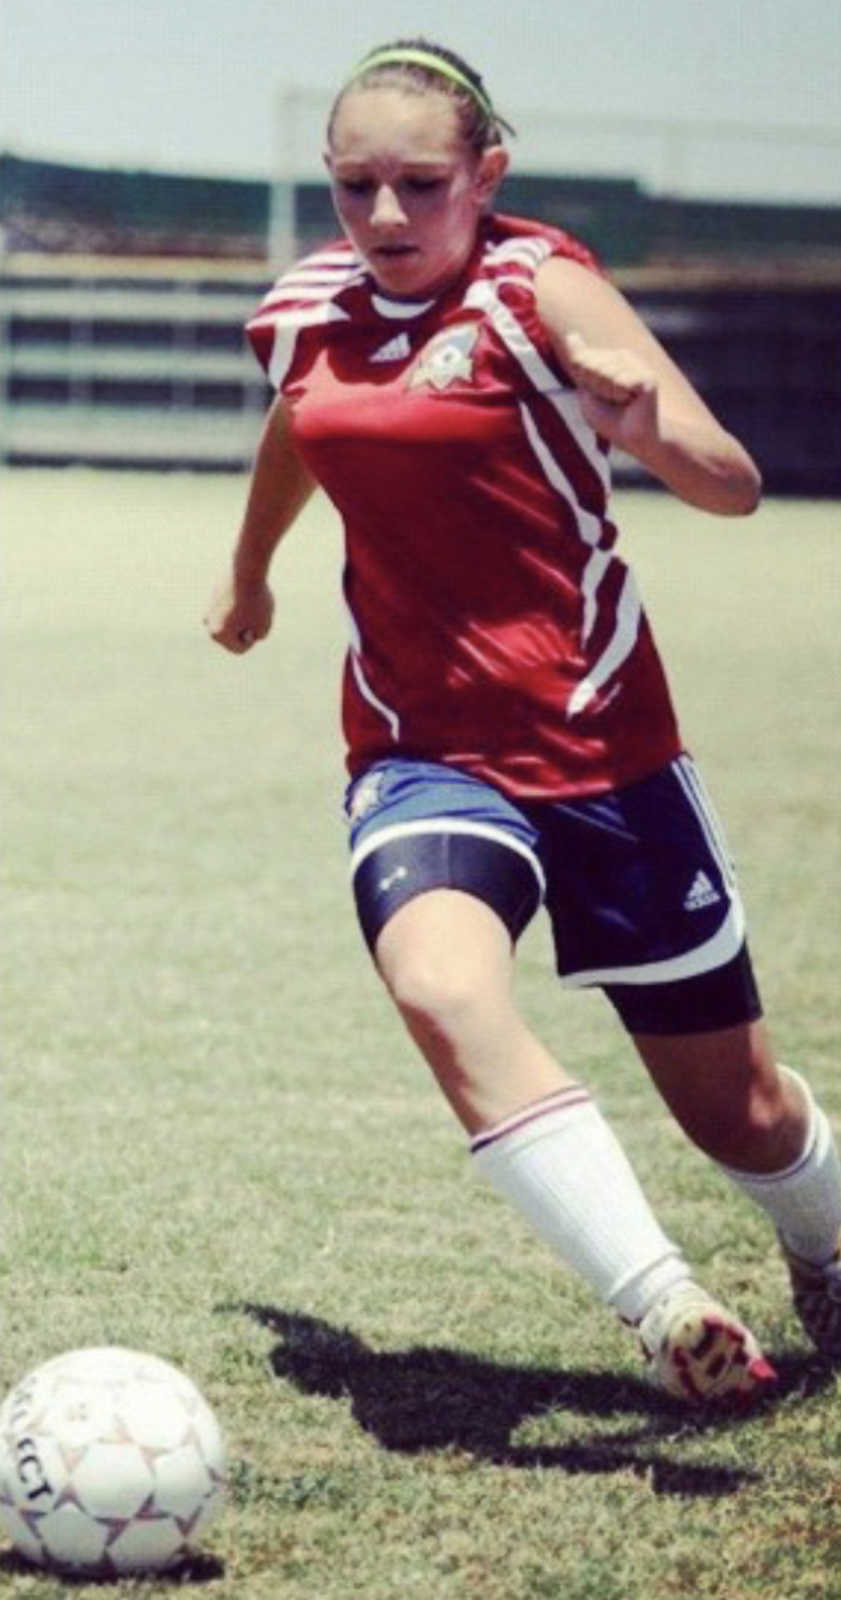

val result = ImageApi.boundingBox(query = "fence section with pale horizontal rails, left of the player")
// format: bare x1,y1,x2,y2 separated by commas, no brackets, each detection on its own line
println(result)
0,258,265,470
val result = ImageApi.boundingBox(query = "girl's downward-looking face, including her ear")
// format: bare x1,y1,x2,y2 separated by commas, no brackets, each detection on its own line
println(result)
325,86,507,299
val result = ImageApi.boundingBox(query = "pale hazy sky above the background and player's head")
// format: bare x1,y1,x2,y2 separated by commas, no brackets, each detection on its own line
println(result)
0,0,841,203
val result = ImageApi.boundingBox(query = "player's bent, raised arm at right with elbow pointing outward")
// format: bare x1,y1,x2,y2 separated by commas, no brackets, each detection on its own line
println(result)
536,259,763,517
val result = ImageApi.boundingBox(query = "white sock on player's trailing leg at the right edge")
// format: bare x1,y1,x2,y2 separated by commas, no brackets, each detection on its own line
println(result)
719,1067,841,1267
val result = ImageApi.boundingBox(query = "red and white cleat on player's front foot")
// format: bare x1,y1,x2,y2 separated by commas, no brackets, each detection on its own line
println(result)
638,1280,777,1405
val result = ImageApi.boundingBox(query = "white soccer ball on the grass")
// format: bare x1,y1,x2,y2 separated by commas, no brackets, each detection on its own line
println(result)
0,1346,225,1576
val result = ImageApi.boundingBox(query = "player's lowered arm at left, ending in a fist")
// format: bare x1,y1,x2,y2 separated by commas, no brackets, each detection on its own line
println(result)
205,395,315,656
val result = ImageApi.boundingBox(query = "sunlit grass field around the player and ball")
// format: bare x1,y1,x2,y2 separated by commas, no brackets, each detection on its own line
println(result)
0,472,841,1600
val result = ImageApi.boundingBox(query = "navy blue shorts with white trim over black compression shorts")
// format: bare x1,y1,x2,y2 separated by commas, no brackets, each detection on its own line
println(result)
345,755,761,1034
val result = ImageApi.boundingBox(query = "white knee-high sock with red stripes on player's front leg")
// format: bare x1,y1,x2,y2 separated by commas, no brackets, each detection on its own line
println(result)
470,1086,689,1323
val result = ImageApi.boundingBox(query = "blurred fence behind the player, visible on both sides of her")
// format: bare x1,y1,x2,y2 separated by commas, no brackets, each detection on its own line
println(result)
0,256,841,494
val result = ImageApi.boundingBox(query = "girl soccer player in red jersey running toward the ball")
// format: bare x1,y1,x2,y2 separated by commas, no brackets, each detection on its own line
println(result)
206,40,841,1402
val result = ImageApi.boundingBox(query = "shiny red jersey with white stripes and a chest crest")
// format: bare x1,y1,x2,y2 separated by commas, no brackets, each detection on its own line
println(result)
248,214,680,800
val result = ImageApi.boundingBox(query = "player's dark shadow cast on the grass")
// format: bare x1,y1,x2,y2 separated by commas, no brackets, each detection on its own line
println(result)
227,1302,831,1496
